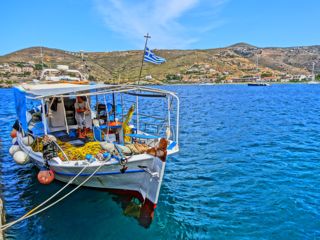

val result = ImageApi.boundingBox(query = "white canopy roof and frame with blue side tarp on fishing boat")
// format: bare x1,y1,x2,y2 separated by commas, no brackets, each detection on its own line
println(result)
14,83,179,143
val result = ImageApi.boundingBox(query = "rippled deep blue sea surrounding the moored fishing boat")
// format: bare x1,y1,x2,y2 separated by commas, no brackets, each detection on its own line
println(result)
0,84,320,240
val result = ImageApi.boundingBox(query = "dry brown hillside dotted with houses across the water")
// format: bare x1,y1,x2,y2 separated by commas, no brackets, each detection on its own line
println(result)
0,43,320,83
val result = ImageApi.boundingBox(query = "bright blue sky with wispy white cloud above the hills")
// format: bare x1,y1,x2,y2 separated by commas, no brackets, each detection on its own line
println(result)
0,0,320,55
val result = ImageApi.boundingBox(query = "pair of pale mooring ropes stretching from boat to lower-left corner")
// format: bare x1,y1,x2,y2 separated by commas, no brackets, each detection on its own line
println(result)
0,165,103,231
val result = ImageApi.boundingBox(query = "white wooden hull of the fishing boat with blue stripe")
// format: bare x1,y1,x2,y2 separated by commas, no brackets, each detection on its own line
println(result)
18,135,165,204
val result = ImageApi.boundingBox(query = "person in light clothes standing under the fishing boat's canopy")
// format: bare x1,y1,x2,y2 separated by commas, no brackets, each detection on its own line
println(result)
74,96,91,138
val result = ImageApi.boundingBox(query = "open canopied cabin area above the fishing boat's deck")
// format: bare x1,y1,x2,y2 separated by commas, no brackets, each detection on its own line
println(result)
14,83,179,160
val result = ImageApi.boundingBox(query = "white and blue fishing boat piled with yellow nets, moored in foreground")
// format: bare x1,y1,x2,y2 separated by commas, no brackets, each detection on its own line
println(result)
10,79,179,226
